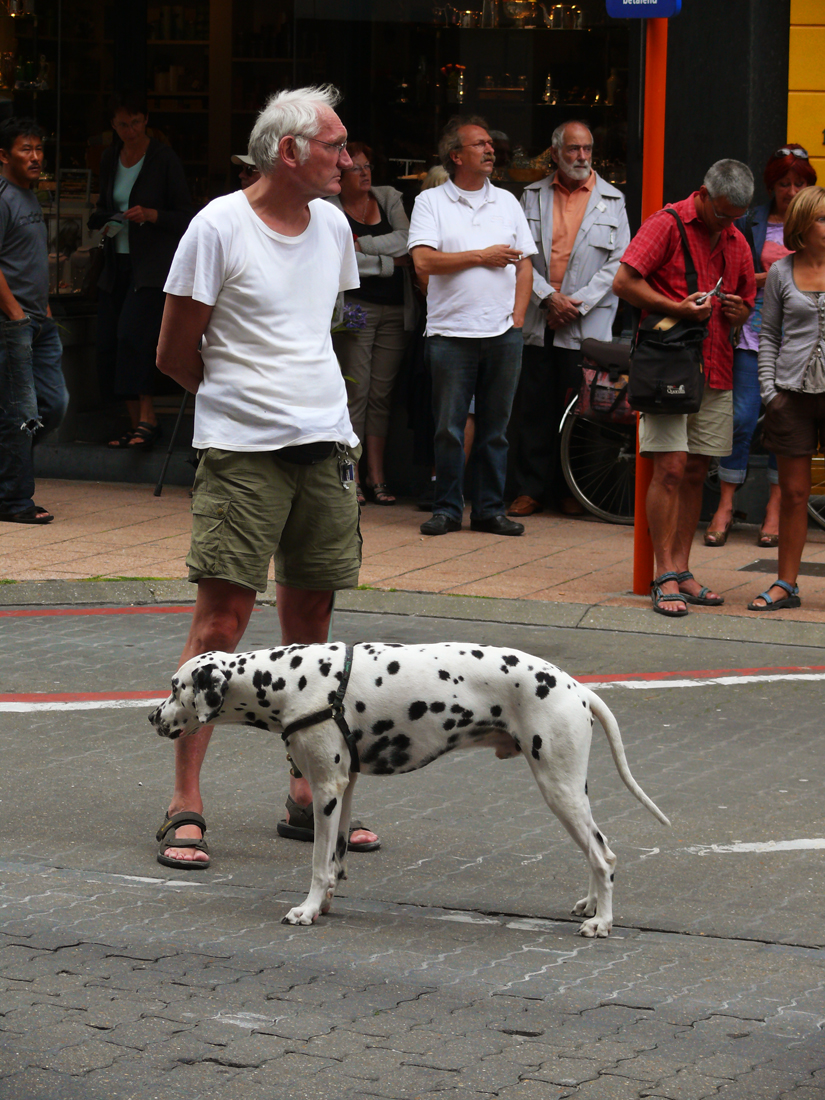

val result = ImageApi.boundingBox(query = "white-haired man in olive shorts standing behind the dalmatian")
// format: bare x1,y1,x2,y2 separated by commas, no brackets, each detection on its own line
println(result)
157,86,378,870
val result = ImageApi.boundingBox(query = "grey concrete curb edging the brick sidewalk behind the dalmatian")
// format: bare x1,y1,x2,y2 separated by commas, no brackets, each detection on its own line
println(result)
0,579,825,648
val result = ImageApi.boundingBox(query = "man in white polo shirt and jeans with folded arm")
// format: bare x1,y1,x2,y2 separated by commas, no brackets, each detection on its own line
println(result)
409,117,536,535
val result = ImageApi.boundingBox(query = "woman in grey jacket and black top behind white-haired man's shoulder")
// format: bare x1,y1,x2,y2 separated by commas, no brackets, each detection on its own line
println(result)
329,141,415,505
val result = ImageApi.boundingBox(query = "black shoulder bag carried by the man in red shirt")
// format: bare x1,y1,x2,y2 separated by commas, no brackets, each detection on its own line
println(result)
628,207,707,415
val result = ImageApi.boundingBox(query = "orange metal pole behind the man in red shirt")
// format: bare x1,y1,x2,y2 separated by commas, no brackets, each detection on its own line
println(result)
634,19,668,596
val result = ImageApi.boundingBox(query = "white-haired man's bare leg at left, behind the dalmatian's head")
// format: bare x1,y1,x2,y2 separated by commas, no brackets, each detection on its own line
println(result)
165,578,255,861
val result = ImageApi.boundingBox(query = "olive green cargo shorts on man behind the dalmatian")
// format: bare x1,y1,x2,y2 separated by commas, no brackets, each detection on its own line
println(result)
191,447,361,592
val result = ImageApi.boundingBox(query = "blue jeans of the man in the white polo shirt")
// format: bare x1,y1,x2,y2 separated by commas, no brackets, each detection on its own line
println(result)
427,329,524,520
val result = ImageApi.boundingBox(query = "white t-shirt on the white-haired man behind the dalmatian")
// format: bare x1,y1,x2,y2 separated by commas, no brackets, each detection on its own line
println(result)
164,191,359,451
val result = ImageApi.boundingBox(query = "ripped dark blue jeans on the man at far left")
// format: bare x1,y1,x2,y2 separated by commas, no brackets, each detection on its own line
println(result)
0,317,68,513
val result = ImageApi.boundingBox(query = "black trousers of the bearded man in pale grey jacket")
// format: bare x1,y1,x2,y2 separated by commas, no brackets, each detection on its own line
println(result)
514,329,582,506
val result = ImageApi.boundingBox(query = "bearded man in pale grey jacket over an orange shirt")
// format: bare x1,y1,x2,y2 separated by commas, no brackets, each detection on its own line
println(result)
507,121,630,516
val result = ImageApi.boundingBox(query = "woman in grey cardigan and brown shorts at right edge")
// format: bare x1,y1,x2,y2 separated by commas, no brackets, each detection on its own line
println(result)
748,187,825,612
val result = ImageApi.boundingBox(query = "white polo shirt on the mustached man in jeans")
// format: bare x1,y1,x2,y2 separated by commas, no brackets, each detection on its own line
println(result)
407,179,536,339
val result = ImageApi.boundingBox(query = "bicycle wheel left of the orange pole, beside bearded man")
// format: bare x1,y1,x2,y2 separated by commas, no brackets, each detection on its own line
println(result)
561,415,636,524
